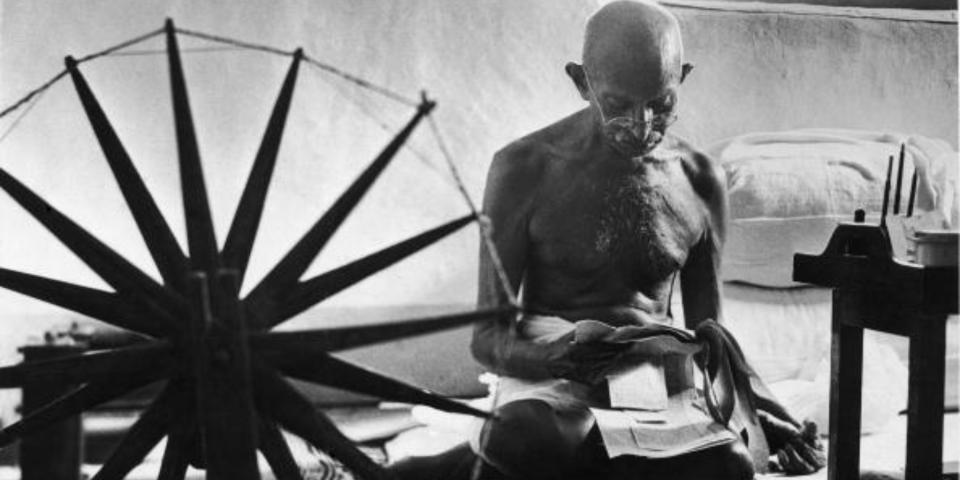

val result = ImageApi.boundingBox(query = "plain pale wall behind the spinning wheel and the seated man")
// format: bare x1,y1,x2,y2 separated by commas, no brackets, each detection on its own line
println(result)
0,0,957,393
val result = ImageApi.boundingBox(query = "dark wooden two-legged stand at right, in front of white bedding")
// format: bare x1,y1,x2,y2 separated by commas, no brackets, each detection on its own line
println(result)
793,223,958,480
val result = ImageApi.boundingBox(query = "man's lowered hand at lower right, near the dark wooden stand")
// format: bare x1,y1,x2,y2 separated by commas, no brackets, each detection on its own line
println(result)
757,410,827,475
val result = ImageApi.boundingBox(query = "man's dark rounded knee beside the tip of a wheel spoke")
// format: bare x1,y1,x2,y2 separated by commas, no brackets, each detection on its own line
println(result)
481,400,590,478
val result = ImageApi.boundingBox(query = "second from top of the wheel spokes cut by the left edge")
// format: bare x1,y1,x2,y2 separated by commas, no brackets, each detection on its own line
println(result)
0,268,165,337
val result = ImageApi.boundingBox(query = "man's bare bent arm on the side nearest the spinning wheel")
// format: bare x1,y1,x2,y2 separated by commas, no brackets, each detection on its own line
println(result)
471,145,564,380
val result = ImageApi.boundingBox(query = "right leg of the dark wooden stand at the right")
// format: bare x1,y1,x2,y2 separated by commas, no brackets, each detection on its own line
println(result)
906,315,947,480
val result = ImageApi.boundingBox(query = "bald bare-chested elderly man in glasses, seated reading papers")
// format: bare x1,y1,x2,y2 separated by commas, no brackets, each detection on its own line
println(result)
386,1,823,480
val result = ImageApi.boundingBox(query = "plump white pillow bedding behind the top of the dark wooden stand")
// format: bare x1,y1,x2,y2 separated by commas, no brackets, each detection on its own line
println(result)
708,129,957,287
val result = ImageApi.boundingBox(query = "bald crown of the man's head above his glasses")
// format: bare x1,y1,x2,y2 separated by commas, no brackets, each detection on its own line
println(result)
583,0,683,94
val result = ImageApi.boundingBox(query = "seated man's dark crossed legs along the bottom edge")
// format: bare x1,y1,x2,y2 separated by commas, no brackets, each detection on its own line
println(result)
393,400,754,480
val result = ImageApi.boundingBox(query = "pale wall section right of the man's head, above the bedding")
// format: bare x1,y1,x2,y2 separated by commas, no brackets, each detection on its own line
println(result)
675,2,957,148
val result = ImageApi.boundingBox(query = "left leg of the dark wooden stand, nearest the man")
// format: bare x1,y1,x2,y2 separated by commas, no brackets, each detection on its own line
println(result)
827,290,863,480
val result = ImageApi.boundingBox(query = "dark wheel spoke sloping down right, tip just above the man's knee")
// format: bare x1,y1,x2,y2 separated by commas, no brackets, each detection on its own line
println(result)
283,354,490,418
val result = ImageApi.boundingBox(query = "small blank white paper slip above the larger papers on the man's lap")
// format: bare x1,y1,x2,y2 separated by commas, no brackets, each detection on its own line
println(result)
607,361,667,411
